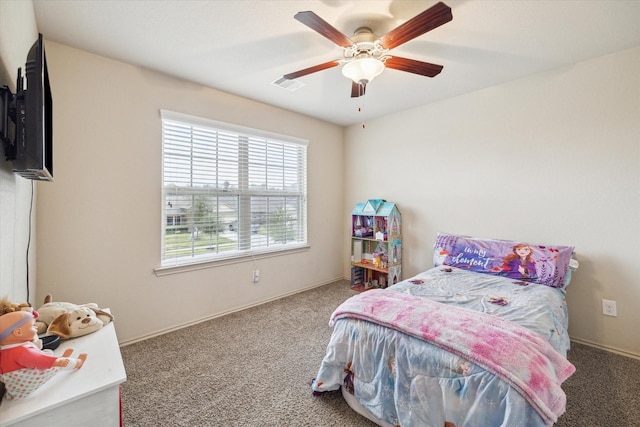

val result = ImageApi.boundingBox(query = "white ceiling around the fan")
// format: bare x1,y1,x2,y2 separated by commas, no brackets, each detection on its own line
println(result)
33,0,640,125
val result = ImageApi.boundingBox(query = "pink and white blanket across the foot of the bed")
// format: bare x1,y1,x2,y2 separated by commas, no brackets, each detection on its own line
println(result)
329,289,575,425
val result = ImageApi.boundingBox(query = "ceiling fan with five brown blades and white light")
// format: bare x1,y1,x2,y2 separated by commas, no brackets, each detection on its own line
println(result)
283,2,453,98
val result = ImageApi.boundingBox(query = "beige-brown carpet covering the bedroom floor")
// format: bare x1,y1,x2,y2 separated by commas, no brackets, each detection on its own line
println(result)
122,281,640,427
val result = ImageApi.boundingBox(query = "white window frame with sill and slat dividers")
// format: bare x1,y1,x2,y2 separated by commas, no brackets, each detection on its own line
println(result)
154,110,309,276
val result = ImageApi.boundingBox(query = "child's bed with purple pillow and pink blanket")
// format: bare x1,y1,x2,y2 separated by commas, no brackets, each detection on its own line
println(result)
312,233,577,427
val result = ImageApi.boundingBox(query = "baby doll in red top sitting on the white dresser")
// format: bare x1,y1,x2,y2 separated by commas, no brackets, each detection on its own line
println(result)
0,310,87,399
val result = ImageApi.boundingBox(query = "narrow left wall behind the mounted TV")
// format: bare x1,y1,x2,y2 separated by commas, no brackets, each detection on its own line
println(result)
0,1,38,302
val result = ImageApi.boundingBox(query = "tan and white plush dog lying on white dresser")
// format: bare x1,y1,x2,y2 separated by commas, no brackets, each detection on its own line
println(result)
36,295,113,339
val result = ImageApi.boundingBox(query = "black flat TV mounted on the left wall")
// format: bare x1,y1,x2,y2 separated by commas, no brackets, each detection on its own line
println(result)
13,34,53,181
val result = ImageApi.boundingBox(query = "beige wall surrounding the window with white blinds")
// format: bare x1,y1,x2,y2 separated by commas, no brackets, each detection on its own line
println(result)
37,43,344,342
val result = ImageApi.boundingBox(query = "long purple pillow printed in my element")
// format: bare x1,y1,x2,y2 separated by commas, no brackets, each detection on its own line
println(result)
433,233,574,288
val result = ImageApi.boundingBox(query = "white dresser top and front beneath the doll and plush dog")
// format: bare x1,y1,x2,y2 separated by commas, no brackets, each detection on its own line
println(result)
0,322,127,427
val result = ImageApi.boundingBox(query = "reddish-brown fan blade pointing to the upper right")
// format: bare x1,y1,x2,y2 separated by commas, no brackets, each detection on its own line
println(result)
380,2,453,49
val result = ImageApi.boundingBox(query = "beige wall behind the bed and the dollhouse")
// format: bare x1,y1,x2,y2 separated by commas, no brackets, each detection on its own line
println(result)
344,47,640,355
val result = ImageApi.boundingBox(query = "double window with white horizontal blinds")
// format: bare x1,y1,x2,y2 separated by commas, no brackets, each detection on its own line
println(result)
161,110,307,267
